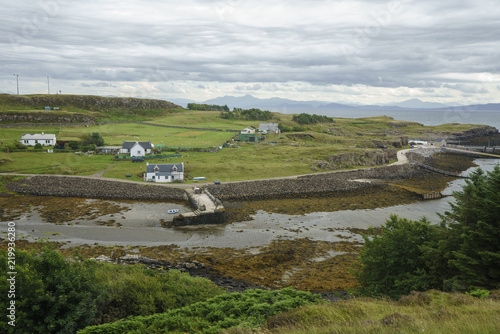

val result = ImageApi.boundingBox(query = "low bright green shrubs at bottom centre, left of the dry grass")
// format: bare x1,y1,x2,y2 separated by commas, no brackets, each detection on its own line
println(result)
79,288,321,334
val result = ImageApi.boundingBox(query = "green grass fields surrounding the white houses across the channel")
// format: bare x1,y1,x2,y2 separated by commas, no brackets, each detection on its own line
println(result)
0,106,492,181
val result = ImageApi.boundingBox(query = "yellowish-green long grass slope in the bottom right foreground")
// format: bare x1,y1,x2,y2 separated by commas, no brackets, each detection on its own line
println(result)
267,291,500,334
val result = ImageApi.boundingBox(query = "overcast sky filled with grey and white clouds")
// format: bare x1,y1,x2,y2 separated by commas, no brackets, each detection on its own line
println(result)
0,0,500,104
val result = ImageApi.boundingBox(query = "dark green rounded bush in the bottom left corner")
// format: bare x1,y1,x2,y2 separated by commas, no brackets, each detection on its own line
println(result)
0,250,103,333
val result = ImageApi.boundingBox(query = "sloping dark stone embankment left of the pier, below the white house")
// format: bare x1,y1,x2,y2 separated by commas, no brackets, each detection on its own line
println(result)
7,175,187,201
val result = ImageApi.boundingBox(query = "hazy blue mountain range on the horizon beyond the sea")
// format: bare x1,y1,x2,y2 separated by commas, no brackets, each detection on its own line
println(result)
169,95,500,114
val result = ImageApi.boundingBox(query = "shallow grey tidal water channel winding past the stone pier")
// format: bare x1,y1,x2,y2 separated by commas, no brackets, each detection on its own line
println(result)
5,159,500,249
